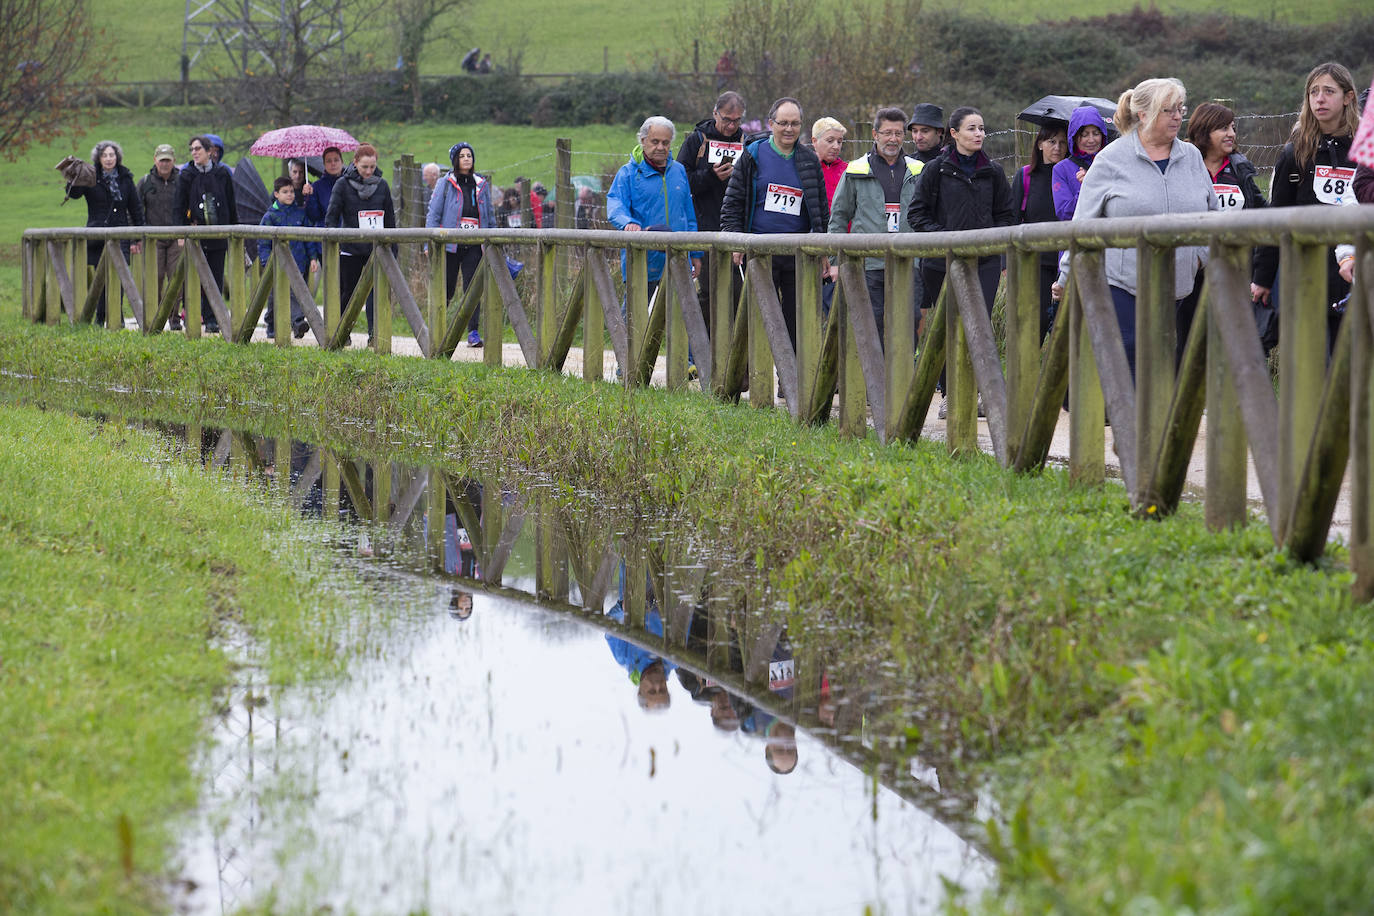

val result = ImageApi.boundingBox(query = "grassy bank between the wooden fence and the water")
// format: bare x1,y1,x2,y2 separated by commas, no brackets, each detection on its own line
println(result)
0,320,1374,912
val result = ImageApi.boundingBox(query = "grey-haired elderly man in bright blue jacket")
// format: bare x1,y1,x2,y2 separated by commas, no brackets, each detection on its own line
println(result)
606,115,701,298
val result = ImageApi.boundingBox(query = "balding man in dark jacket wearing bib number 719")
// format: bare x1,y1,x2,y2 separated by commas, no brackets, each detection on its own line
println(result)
720,98,830,349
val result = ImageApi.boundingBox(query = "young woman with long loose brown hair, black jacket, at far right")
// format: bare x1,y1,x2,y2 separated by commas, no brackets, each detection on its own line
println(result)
1250,62,1360,329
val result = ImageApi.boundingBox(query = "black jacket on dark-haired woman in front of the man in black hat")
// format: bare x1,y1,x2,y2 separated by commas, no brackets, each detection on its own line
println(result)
907,146,1017,266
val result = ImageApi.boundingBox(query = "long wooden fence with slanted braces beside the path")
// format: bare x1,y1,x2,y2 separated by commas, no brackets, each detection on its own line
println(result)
23,207,1374,599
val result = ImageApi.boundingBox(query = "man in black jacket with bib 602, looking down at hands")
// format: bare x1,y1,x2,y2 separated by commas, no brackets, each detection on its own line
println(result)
677,92,745,331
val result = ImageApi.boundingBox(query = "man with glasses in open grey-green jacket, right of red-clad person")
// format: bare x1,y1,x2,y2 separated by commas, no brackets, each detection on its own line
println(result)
830,108,925,343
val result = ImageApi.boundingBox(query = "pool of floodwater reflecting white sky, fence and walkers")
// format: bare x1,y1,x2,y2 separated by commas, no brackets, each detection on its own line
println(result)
123,427,991,913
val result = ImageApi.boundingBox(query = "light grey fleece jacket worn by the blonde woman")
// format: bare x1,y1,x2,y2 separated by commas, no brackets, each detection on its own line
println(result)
1073,130,1221,299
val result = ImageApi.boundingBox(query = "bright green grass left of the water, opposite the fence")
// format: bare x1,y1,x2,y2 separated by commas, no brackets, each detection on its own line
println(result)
0,405,373,913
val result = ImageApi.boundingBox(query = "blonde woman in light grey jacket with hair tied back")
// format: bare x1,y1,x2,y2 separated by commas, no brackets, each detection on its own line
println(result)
1059,78,1221,379
